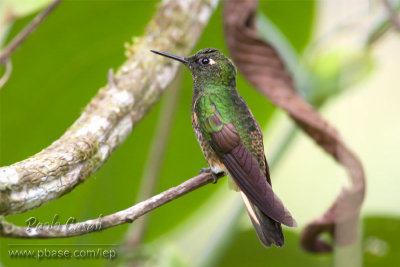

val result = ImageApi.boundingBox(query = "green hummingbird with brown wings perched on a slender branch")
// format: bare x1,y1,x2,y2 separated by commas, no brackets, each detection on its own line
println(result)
151,48,297,247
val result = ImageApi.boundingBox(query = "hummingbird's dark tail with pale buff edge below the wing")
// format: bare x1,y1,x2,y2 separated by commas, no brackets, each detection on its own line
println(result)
240,191,285,247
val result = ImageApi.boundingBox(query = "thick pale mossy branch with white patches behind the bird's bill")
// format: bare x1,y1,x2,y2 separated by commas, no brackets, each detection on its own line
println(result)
0,0,217,215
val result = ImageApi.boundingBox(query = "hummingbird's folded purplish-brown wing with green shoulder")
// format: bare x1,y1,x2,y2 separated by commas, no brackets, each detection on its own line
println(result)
199,105,296,227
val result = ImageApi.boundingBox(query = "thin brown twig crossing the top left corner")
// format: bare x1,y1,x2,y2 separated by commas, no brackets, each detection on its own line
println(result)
0,0,62,64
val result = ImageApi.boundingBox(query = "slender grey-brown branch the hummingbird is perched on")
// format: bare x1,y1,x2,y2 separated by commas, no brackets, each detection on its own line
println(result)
0,172,223,239
